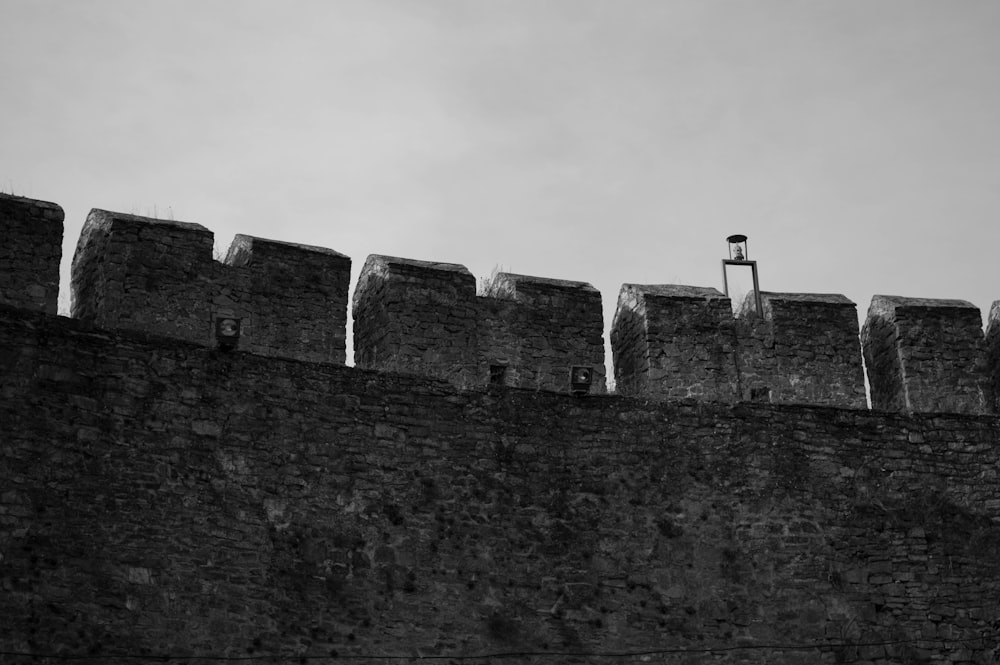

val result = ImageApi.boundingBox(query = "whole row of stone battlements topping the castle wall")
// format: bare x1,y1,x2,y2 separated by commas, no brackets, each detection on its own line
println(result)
0,195,1000,414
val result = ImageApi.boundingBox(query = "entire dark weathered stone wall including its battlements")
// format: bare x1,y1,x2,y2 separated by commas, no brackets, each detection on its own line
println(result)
0,200,1000,665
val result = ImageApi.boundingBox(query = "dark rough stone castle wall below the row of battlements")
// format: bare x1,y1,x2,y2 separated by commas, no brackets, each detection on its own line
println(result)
0,308,1000,665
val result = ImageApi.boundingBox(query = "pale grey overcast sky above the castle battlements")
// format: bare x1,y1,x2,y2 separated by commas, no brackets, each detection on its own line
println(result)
0,0,1000,364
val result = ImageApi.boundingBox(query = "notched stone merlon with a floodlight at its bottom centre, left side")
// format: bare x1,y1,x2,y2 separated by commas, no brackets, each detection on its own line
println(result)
72,210,351,363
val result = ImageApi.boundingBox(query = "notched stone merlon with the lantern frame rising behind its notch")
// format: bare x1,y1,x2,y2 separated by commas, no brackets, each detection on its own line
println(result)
611,284,866,408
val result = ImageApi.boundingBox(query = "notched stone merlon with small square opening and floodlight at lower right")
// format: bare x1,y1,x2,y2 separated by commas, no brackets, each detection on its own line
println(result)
353,255,605,393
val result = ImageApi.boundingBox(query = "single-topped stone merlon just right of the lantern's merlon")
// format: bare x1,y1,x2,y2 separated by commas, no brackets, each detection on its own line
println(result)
861,295,990,413
